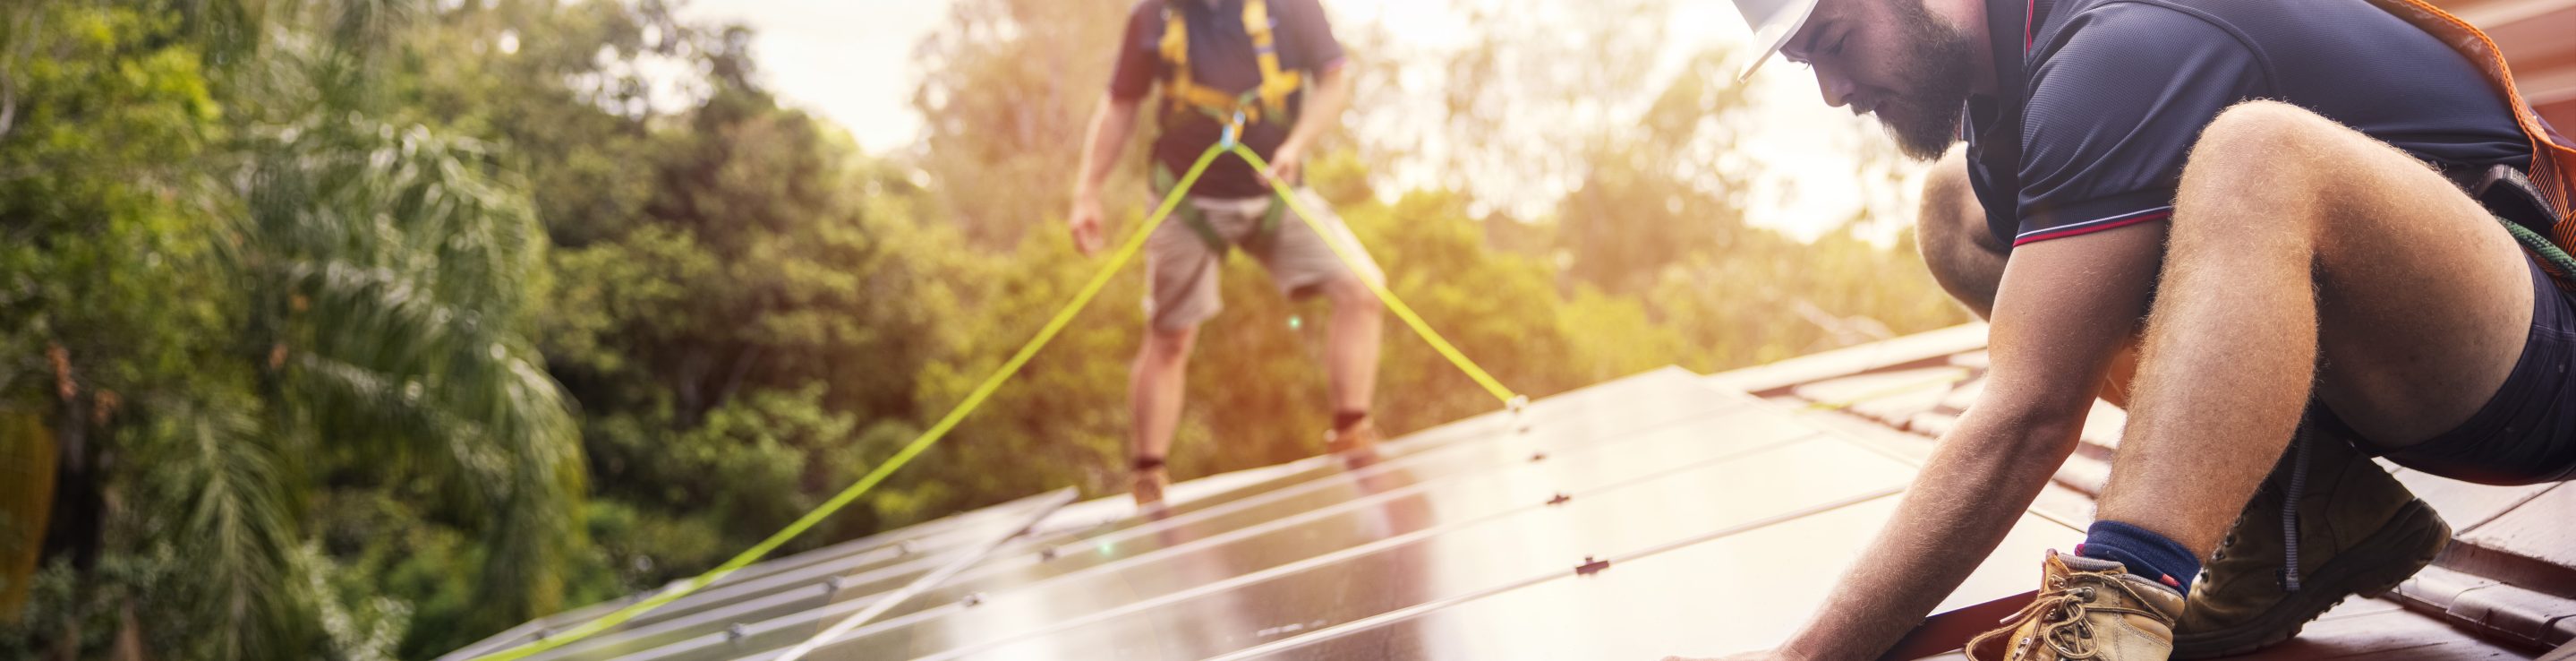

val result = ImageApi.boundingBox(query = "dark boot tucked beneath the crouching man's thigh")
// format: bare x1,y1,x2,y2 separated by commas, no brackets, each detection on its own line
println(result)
2174,424,2450,658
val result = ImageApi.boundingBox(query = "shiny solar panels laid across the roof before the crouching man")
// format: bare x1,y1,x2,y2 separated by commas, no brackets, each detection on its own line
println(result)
453,369,2079,661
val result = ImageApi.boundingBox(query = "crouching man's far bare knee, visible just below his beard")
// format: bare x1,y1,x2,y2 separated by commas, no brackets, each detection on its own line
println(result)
1914,147,2004,318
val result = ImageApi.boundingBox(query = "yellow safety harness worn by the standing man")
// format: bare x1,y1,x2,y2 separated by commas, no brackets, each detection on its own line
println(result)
1151,0,1306,253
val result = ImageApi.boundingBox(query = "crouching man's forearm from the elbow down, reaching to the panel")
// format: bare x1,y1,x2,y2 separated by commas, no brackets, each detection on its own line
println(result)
1785,410,2084,658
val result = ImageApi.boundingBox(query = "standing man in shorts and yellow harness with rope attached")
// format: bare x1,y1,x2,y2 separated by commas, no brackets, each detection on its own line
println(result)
1069,0,1383,506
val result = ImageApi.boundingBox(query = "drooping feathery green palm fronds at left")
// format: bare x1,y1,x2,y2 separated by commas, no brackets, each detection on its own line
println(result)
237,116,582,617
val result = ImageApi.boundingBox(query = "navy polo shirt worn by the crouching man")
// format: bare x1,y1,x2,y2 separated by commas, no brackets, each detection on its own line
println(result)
1966,0,2529,245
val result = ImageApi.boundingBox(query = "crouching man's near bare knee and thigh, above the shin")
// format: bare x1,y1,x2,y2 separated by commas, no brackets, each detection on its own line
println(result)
2156,100,2532,444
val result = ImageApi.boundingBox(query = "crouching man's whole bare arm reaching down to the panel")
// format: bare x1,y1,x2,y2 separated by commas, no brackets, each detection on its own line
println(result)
1741,222,2164,658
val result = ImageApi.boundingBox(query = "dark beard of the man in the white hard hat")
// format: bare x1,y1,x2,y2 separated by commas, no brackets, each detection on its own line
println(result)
1870,0,1975,160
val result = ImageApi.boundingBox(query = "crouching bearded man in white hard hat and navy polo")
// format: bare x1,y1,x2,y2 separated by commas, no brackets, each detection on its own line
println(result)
1700,0,2576,661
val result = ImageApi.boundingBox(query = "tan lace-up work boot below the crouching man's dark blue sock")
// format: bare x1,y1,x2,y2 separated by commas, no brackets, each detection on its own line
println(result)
1966,550,2182,661
